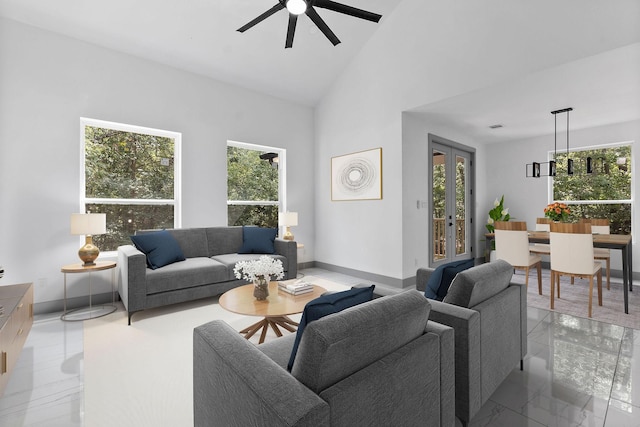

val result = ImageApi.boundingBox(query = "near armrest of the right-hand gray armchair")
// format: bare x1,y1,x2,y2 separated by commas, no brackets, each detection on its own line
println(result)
429,300,482,420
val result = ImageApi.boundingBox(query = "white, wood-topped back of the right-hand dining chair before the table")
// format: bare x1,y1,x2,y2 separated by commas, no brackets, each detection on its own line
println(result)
549,223,593,274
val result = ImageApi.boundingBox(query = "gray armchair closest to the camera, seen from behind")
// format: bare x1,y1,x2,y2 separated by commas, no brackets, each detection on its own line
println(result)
193,290,455,427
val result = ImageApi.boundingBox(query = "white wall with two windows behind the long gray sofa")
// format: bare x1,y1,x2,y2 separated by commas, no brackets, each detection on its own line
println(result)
0,20,315,303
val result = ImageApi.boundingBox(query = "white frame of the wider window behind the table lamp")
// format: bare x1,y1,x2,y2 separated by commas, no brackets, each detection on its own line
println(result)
79,117,182,256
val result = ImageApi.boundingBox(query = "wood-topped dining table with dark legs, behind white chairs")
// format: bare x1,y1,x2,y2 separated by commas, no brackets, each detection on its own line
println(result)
485,231,633,314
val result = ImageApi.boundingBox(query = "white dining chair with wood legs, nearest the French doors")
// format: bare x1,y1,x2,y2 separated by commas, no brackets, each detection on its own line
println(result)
493,221,542,295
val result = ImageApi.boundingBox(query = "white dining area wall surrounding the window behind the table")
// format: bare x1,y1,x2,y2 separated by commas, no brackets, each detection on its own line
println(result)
482,121,640,271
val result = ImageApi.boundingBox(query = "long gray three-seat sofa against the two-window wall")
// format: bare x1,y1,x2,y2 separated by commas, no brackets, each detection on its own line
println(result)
118,227,298,324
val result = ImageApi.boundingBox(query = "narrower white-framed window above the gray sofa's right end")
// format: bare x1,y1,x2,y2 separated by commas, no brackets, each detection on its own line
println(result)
227,141,284,228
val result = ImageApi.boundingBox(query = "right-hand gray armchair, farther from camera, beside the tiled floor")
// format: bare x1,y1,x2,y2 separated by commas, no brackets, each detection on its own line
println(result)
416,260,527,425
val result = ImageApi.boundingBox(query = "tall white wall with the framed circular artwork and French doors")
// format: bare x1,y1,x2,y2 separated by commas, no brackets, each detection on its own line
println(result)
315,0,638,282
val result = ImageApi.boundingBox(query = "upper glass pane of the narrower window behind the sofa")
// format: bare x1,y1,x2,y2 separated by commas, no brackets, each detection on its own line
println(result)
227,146,278,202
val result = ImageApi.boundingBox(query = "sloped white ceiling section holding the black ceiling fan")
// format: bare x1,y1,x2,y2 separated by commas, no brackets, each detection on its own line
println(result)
0,0,400,105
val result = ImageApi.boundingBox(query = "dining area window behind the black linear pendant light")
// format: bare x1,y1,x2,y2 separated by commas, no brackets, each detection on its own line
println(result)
552,144,632,234
